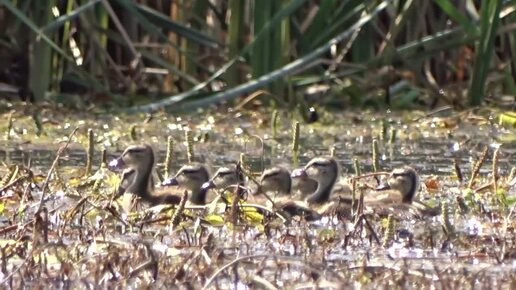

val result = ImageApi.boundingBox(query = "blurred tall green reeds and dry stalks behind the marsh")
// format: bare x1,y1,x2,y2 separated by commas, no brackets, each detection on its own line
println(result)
0,0,516,111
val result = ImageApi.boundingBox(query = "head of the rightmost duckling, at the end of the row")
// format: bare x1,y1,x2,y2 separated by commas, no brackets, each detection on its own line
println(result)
380,166,419,203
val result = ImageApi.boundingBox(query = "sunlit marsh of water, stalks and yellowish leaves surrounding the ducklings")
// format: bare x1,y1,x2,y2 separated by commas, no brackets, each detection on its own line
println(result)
0,105,516,289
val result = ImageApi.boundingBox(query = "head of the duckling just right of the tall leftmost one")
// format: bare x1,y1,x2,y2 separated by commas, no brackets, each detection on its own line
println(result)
162,164,210,204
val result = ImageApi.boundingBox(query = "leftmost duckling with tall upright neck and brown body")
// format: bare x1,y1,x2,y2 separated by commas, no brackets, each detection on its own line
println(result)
109,144,208,209
